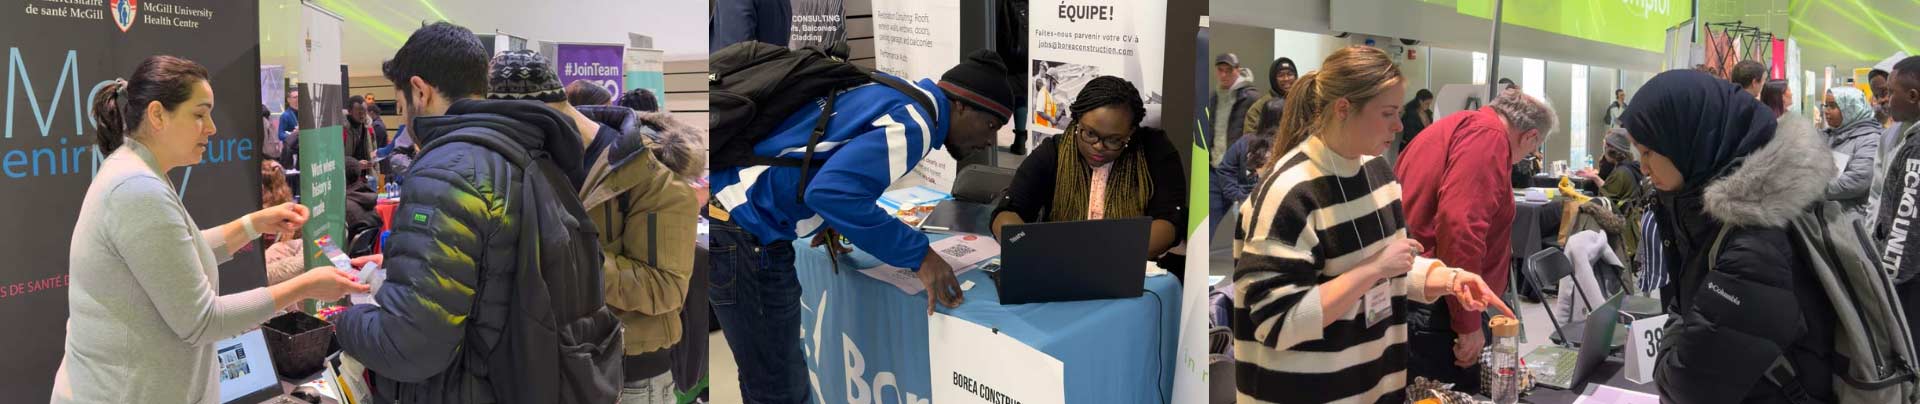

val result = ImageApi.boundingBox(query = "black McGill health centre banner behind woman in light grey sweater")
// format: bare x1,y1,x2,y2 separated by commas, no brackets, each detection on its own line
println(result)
0,0,265,402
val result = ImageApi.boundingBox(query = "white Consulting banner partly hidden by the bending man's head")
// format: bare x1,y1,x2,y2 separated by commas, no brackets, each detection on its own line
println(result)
874,0,960,192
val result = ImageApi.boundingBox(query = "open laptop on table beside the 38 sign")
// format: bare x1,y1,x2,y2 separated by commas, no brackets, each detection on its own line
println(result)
1524,294,1626,391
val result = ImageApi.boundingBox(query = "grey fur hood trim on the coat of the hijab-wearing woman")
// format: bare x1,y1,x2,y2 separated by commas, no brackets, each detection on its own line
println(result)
1703,115,1837,227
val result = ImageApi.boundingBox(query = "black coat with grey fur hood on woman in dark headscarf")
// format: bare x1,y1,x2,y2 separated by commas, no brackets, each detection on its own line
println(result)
1655,114,1836,404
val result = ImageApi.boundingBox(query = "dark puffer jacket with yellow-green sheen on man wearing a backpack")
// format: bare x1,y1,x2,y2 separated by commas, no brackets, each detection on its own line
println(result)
334,100,595,402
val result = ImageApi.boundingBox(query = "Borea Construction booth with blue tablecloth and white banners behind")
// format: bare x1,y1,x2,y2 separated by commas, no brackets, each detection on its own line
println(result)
793,0,1208,402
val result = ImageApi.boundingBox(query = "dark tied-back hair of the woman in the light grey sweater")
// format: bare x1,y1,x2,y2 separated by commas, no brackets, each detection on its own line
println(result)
92,54,209,154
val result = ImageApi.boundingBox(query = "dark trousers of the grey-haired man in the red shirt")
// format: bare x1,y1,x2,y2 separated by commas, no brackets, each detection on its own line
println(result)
1407,302,1488,392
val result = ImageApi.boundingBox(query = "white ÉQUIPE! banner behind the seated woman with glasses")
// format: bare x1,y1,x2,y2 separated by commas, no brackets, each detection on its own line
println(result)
1027,0,1167,142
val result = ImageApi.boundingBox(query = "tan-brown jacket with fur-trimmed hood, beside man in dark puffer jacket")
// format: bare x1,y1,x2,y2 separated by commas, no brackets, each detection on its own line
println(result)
576,106,707,369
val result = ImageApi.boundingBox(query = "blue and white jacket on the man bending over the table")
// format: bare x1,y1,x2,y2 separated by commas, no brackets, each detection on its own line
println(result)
710,79,950,269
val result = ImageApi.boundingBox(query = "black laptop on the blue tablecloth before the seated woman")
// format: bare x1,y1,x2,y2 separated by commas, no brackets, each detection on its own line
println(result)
995,217,1152,304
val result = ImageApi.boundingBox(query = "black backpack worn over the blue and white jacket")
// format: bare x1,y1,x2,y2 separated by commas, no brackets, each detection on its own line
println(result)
707,42,939,202
